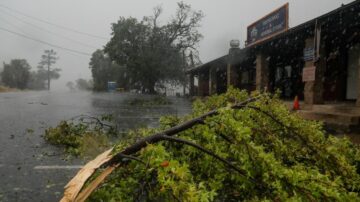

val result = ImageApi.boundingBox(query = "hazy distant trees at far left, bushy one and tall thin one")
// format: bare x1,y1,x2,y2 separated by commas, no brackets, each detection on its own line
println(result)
0,50,60,90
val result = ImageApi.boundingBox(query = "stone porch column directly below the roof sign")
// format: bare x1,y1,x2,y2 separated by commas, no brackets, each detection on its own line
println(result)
256,53,269,91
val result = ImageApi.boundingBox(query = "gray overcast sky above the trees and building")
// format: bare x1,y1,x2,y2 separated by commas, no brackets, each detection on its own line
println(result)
0,0,352,90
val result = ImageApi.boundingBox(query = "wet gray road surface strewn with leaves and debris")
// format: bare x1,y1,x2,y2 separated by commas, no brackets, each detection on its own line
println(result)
0,92,191,201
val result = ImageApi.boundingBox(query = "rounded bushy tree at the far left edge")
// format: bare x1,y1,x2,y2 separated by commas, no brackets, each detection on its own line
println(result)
1,59,31,89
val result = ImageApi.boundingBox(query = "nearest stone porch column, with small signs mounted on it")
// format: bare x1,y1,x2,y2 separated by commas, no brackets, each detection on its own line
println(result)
304,37,326,105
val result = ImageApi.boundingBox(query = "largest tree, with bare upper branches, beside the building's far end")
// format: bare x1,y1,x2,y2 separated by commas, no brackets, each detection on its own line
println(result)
105,2,203,93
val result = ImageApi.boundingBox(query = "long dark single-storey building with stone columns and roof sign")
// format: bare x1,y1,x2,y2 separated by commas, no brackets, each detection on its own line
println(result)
187,0,360,130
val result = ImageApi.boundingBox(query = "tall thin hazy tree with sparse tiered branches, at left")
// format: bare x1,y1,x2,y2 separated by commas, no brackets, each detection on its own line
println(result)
39,49,60,90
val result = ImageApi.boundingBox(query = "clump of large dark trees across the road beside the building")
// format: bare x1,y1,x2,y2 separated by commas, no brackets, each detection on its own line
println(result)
89,2,204,93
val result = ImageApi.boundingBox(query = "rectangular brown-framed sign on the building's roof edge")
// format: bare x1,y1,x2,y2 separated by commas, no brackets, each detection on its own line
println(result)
247,3,289,46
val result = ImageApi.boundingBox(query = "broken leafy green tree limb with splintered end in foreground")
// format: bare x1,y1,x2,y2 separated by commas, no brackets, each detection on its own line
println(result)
62,89,360,201
